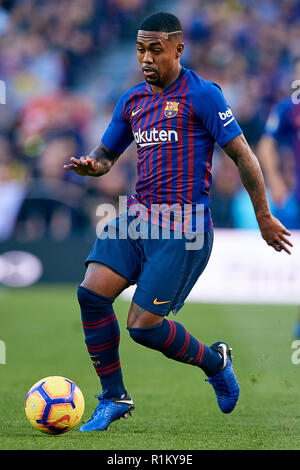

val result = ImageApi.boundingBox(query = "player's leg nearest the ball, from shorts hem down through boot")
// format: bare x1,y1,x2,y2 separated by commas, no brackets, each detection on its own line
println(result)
78,263,134,431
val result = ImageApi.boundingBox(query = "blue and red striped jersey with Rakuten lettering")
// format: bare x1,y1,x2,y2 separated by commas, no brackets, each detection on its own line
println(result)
102,68,242,232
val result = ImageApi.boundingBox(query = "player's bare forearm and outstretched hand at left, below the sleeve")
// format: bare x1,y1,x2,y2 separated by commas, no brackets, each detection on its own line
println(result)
64,142,120,176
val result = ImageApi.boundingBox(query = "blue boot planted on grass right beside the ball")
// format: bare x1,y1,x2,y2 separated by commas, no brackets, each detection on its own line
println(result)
80,390,134,431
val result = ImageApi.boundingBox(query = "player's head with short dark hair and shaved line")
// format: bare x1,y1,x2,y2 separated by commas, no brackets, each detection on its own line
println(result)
137,12,184,86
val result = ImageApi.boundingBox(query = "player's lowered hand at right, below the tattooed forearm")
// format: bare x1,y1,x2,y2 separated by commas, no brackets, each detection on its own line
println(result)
258,215,293,255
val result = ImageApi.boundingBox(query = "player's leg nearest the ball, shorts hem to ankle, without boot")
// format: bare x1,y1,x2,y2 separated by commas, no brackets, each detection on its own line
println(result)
78,262,129,398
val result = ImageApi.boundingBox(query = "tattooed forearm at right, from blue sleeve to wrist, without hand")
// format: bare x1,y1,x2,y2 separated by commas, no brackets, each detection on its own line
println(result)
223,135,270,218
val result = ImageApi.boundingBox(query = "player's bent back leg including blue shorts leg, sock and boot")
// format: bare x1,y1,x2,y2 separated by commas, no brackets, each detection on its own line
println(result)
128,233,238,413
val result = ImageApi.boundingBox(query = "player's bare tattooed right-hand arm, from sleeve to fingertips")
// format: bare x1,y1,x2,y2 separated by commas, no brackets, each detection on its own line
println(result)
223,134,293,254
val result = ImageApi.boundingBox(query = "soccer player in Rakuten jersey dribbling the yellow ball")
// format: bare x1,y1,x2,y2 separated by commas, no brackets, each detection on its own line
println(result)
65,12,292,431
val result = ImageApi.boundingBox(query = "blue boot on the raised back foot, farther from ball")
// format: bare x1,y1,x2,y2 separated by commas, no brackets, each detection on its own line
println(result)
205,342,240,413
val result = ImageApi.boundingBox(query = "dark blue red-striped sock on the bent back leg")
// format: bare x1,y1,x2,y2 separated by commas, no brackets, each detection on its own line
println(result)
128,319,223,377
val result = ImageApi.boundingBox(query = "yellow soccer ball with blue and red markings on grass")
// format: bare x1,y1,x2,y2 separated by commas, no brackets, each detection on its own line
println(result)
25,376,84,434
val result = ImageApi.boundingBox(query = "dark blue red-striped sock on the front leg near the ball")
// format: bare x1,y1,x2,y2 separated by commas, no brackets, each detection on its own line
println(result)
77,286,126,398
